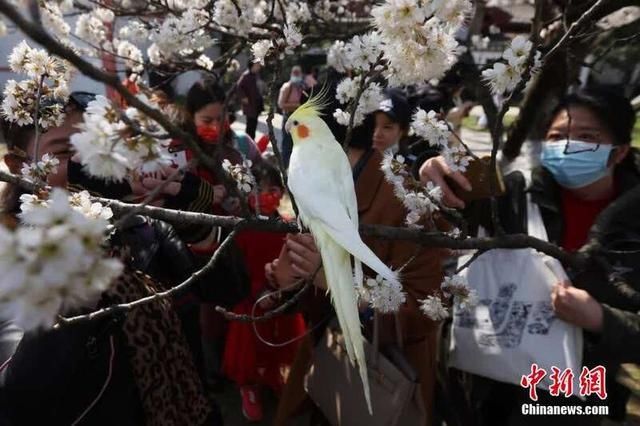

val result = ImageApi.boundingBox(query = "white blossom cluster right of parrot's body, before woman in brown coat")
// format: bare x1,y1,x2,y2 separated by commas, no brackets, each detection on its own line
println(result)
380,151,442,229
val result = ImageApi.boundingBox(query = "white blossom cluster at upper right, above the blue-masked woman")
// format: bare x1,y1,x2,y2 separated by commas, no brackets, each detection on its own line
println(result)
482,35,542,96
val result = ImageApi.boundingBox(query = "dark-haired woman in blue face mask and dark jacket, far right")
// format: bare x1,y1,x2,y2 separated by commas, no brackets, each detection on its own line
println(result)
420,90,640,426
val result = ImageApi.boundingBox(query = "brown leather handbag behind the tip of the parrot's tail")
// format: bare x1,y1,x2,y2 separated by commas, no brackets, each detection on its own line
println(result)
305,314,426,426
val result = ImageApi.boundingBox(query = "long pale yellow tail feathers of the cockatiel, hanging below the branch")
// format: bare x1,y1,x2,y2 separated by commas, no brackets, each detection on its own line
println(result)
312,230,373,414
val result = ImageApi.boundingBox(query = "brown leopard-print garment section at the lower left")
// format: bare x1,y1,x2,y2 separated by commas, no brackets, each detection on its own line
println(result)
104,269,211,426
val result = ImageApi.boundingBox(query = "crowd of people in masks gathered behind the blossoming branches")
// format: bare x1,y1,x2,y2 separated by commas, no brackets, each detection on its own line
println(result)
0,59,640,425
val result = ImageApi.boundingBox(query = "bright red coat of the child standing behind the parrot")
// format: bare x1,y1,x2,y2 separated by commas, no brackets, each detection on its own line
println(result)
223,231,305,391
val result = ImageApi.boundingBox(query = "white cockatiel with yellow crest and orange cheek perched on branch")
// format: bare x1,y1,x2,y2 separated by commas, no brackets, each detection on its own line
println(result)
285,94,399,413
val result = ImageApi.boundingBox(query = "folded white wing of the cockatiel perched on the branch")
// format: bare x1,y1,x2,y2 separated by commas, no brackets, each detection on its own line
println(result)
289,144,399,283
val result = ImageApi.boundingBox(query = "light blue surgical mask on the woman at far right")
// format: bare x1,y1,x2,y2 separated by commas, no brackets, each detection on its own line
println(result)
541,139,613,189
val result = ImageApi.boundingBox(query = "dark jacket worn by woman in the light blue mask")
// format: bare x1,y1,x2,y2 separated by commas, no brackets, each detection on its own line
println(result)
456,149,640,424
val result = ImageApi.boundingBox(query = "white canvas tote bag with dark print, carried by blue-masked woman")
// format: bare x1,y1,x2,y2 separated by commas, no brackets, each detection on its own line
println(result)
449,195,583,389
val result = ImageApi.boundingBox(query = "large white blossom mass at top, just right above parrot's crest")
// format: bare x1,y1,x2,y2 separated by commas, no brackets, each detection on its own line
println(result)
327,0,471,129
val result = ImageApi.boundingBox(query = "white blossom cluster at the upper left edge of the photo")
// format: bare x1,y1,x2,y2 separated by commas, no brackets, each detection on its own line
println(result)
2,41,71,129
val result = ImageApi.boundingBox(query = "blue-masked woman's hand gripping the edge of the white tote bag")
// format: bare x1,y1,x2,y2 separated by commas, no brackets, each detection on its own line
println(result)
551,282,603,333
